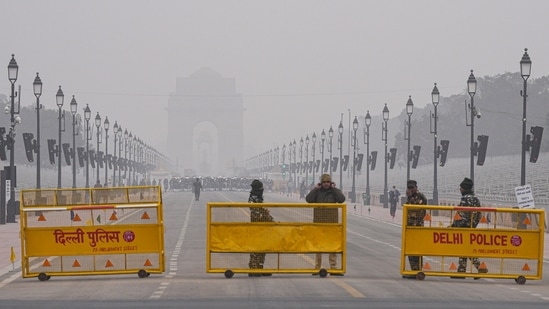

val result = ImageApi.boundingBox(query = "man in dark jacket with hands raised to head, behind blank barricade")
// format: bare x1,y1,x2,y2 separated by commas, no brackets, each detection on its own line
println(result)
305,174,345,276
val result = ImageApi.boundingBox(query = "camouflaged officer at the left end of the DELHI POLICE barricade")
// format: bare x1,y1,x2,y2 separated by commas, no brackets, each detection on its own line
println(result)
403,180,427,279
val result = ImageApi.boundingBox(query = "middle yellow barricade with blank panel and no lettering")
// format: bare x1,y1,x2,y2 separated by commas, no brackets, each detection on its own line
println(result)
206,203,346,278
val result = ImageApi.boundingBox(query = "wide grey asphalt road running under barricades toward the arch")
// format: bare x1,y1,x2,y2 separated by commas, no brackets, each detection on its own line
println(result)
0,191,549,309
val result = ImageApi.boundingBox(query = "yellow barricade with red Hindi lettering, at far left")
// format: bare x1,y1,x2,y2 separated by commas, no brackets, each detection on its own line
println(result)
20,186,165,281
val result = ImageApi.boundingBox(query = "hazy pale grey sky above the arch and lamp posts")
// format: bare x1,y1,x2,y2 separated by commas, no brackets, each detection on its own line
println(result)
0,0,549,161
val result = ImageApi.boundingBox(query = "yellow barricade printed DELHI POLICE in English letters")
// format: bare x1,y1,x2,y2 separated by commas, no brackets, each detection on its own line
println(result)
400,204,545,284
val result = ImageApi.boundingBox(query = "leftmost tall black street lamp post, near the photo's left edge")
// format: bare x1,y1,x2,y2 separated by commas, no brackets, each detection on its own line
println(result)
5,54,19,224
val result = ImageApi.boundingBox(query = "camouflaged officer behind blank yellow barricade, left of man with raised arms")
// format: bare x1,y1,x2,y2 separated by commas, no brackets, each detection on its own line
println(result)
248,179,274,277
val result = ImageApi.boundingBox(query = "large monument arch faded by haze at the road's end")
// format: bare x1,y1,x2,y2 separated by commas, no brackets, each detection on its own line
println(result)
167,68,244,176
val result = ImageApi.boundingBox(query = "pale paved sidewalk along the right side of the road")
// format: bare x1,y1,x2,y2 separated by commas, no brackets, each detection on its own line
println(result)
347,203,549,263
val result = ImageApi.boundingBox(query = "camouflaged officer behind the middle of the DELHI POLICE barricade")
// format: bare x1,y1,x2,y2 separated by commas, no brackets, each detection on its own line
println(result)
452,178,488,273
